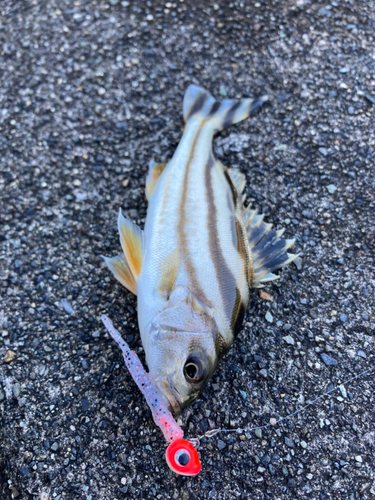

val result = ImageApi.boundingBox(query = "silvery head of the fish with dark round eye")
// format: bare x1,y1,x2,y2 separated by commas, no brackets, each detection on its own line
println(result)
146,287,223,414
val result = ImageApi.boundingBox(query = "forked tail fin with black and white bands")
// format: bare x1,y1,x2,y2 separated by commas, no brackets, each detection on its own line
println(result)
183,85,268,132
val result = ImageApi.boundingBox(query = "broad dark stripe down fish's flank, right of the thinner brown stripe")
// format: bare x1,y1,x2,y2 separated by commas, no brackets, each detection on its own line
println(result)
205,154,236,318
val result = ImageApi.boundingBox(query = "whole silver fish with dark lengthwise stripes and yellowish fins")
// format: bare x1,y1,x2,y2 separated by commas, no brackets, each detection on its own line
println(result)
104,85,297,415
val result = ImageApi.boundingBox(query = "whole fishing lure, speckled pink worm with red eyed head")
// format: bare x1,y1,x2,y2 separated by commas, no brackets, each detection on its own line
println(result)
101,315,202,476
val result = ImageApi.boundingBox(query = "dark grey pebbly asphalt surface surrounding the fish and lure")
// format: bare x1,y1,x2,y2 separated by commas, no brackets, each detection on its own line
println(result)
0,0,375,500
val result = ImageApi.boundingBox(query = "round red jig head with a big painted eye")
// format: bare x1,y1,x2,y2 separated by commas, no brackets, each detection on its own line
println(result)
165,439,202,476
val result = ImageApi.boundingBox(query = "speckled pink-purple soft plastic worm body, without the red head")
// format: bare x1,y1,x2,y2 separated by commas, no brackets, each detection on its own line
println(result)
101,315,184,443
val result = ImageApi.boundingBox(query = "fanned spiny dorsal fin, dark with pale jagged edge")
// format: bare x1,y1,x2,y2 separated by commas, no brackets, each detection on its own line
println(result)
244,210,301,288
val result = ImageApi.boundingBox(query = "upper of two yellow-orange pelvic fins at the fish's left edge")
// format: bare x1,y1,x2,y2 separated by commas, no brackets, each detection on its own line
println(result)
118,209,143,281
